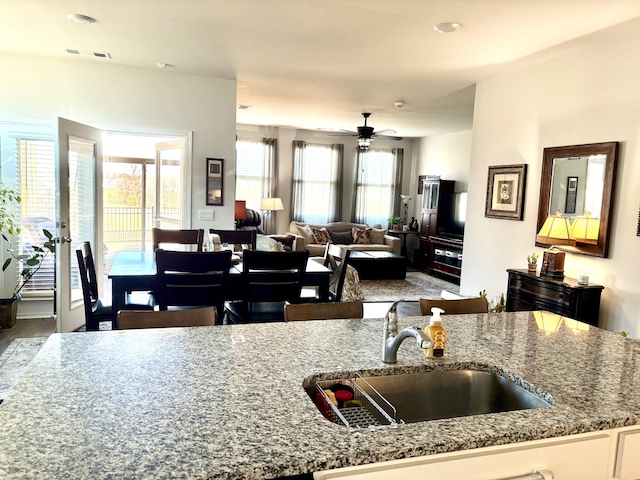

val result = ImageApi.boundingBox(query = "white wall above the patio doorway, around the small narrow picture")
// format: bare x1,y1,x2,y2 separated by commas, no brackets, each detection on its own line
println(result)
0,53,236,316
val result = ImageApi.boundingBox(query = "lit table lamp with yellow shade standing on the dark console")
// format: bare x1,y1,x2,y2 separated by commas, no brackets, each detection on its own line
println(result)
536,210,576,278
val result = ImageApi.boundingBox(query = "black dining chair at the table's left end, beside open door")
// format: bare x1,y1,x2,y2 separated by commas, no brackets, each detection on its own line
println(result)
76,242,155,331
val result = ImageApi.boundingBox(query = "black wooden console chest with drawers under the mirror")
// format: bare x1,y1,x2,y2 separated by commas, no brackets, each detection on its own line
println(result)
507,269,604,327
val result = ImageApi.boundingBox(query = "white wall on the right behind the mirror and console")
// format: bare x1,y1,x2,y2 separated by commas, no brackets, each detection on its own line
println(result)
461,31,640,338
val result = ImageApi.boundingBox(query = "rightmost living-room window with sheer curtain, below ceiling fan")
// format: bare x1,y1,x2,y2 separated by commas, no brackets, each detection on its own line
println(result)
353,148,404,227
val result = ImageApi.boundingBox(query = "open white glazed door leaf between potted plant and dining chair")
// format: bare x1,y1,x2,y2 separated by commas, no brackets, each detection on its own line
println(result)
56,118,103,332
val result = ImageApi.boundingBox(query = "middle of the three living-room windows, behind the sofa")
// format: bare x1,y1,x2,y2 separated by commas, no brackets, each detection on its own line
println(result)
291,141,344,224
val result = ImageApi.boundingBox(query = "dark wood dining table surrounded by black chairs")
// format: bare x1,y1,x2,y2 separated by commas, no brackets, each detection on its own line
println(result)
108,252,331,329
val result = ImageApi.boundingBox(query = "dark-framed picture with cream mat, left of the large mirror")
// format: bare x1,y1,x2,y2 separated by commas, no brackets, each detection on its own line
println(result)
484,164,527,220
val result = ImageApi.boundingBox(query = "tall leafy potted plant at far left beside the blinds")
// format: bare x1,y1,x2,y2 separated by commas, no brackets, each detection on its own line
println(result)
0,184,56,328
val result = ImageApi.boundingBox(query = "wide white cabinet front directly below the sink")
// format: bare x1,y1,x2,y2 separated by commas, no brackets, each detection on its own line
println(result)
314,433,612,480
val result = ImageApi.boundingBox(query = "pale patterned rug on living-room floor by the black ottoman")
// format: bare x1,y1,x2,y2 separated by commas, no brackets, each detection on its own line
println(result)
360,272,460,302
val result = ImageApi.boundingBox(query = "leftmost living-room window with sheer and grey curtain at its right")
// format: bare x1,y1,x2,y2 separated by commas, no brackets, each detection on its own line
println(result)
236,138,278,232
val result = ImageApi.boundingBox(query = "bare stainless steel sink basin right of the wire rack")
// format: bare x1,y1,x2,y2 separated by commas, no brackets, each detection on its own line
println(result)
356,370,549,423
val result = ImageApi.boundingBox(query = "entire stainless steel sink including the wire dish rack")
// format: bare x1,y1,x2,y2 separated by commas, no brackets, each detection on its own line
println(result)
307,369,553,428
